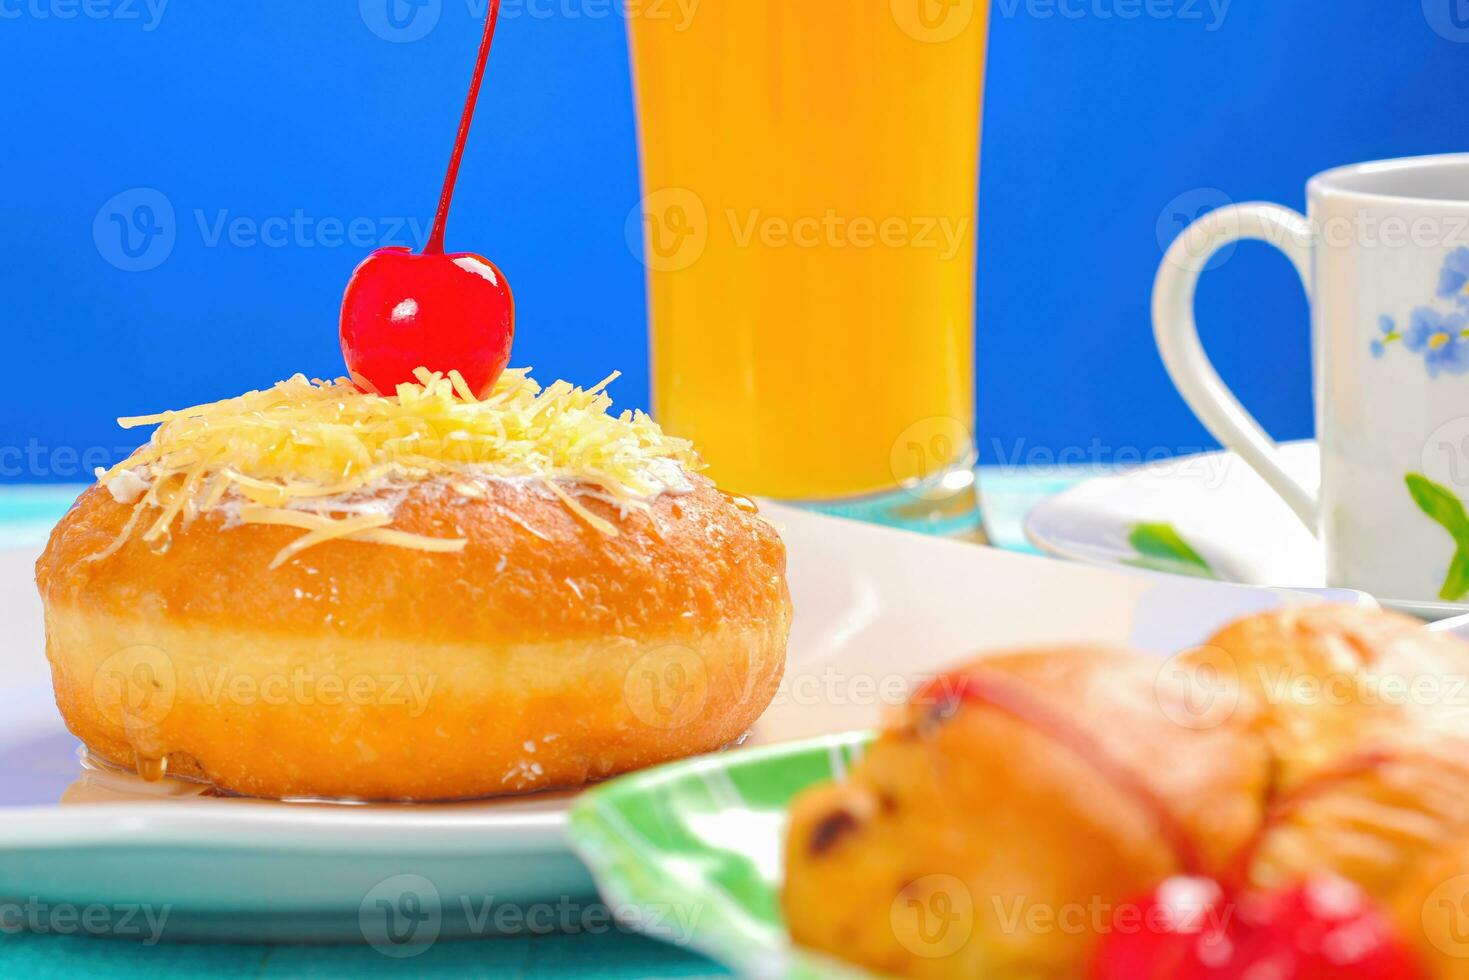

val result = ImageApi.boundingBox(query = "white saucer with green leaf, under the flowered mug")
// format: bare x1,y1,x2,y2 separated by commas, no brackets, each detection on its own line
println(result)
1025,441,1469,620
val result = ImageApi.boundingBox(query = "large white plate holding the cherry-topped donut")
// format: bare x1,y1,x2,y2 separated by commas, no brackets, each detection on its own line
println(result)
0,505,1371,942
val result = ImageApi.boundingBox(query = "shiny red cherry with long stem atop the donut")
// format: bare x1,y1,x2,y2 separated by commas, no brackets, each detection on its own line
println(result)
341,0,516,395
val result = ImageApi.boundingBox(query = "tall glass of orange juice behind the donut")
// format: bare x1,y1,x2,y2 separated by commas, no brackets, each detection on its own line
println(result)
629,0,989,536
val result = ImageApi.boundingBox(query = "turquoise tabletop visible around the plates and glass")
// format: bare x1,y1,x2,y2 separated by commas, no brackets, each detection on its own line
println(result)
0,470,1075,980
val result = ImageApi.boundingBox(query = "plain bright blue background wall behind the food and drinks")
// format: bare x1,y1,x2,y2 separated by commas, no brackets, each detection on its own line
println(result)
0,0,1469,480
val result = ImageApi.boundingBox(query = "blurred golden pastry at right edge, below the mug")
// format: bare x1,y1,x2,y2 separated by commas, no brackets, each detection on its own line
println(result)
1198,605,1469,901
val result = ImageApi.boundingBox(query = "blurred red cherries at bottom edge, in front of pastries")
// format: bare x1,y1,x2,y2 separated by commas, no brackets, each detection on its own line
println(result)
1091,877,1423,980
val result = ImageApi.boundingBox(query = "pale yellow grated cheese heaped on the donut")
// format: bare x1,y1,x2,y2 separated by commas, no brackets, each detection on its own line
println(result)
94,367,702,569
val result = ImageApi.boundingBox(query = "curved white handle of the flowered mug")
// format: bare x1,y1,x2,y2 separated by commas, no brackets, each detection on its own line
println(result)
1153,204,1319,533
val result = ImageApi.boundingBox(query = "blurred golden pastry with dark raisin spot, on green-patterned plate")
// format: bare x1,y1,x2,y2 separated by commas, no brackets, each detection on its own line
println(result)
782,646,1269,980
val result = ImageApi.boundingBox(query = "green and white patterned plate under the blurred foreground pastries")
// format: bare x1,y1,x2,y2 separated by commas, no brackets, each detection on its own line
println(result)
570,732,873,980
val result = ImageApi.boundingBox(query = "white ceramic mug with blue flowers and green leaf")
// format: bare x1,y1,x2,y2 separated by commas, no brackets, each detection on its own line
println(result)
1153,154,1469,602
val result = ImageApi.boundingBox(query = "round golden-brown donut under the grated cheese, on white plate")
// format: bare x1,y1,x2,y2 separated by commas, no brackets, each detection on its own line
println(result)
37,371,790,801
